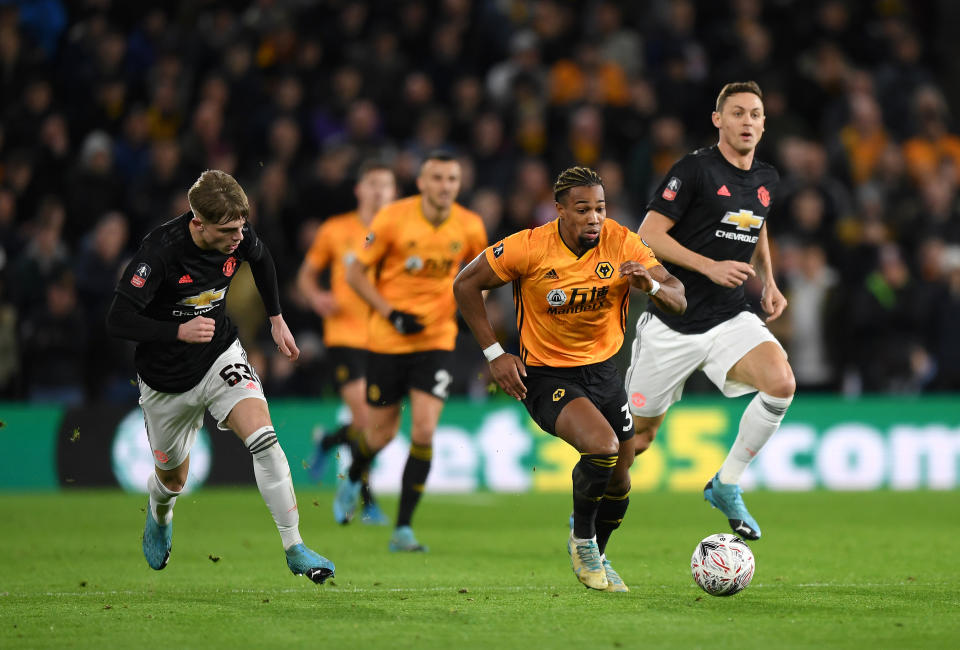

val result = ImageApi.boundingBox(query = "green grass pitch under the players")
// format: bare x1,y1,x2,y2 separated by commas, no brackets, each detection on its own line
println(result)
0,487,960,650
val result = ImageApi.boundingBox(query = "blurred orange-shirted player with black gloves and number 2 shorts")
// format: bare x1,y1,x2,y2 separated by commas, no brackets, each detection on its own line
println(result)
334,152,487,551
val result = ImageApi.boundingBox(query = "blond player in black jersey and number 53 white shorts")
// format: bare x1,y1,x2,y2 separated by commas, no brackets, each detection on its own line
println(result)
107,170,334,584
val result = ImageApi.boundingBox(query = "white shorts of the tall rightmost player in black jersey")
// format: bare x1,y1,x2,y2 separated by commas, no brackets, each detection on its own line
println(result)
624,311,786,417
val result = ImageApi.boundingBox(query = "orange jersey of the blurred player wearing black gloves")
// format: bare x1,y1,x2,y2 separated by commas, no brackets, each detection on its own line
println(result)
357,195,487,354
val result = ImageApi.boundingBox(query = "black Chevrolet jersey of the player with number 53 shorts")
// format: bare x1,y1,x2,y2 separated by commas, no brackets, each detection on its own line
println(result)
116,212,269,393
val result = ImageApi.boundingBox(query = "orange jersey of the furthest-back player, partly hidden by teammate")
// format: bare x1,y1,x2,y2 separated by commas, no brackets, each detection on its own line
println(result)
307,212,372,348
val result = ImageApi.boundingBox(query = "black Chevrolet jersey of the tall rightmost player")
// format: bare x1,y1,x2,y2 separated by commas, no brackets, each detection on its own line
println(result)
647,145,780,334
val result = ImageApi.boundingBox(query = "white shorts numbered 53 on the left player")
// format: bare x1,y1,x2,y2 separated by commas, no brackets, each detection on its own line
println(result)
137,341,267,469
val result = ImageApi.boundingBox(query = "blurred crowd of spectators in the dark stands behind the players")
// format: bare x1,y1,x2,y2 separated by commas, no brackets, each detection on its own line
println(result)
0,0,960,404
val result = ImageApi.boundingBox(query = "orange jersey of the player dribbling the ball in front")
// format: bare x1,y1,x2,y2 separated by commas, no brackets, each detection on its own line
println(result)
485,219,660,368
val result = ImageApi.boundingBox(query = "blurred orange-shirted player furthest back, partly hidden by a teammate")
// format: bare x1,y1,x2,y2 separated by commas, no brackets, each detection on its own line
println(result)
297,160,397,525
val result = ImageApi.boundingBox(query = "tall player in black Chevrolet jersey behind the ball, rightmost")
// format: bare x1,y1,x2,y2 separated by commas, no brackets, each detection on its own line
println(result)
625,81,796,539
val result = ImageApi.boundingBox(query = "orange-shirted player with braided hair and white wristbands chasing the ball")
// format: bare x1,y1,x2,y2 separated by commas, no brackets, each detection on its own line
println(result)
453,167,686,591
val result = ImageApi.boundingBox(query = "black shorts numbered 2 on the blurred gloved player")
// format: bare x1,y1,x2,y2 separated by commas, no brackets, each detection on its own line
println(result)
367,350,453,406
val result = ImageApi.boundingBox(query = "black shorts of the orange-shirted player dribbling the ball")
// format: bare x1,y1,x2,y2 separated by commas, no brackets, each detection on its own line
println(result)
523,359,633,441
